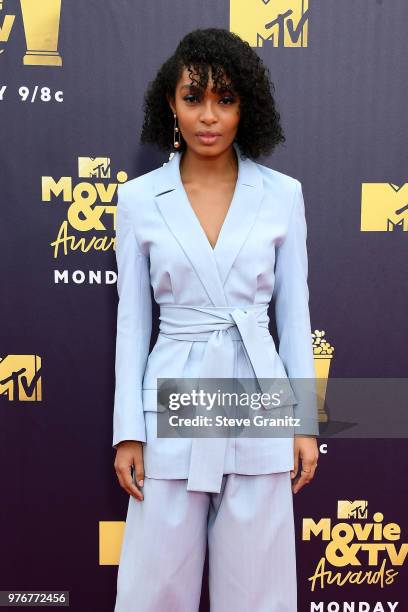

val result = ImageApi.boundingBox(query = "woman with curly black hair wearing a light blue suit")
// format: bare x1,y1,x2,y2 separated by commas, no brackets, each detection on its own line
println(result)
113,28,318,612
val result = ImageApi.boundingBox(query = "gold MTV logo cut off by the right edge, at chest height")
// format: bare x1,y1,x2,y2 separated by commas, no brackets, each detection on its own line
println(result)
361,183,408,232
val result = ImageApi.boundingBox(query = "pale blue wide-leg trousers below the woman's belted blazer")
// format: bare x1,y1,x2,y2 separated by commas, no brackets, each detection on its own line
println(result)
114,472,297,612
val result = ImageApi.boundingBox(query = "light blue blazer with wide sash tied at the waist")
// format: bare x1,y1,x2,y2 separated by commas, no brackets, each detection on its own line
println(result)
113,142,318,492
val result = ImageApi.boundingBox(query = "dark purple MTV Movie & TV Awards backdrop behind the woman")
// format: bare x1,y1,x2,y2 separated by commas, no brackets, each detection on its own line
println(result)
0,0,408,612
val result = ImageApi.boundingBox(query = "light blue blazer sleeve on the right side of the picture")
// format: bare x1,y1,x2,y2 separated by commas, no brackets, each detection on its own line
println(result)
273,180,319,436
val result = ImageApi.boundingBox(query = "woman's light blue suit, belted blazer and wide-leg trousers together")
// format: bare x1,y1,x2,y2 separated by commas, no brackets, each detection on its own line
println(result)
113,143,318,612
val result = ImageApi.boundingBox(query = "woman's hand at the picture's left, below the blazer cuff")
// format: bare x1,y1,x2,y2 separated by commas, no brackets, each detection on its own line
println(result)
114,440,144,501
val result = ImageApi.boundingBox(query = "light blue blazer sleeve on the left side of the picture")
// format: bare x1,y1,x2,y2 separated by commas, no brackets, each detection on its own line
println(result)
113,185,152,448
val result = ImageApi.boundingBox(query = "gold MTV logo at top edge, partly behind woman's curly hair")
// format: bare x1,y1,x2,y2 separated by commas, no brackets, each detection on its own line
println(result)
230,0,309,47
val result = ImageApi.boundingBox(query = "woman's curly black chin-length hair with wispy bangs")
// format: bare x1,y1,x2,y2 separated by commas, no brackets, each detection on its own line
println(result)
140,28,285,159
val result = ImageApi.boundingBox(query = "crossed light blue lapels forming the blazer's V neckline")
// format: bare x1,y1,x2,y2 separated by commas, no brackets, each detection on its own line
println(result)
154,143,263,306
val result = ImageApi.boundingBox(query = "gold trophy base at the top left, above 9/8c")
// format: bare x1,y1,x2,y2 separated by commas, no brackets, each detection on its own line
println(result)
20,0,62,66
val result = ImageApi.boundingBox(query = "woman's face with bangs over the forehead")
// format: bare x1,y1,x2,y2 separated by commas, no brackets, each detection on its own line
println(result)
169,68,240,155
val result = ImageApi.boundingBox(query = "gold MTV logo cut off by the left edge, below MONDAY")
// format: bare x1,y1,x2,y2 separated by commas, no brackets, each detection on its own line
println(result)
0,355,42,402
